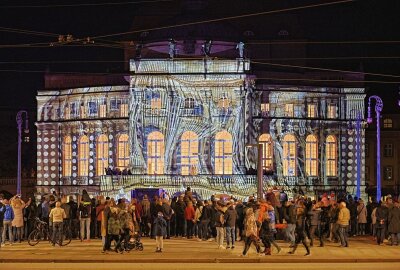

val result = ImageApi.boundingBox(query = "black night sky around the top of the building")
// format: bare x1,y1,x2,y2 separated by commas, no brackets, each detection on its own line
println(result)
0,0,400,175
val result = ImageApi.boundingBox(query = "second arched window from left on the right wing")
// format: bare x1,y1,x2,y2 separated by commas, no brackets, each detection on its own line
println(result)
282,134,297,176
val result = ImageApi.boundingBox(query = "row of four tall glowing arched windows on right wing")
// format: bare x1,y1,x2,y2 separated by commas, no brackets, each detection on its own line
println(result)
259,134,337,177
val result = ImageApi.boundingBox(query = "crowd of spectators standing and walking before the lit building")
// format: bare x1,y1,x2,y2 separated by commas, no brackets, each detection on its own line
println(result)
0,187,400,256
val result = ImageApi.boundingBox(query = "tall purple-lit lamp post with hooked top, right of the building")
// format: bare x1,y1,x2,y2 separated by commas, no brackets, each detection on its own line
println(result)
367,96,383,203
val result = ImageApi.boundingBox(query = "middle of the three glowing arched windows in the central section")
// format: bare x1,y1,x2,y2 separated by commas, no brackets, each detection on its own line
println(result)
181,131,199,175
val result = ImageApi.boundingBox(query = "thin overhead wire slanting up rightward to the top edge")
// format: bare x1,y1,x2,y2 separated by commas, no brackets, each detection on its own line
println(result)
87,0,357,40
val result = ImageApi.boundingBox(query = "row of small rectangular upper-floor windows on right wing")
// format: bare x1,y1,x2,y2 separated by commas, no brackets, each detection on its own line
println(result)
261,103,337,119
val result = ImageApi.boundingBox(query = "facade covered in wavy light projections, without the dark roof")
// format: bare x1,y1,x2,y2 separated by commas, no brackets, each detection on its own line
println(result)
37,57,365,197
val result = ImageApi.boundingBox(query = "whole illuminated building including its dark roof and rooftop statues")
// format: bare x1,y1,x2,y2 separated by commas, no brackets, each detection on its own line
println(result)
37,1,365,197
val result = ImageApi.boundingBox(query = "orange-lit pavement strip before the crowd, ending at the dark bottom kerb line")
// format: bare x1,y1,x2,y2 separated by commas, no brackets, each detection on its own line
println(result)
0,238,400,263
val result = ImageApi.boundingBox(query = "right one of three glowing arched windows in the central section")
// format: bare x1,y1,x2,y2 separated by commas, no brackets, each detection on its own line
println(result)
214,130,232,174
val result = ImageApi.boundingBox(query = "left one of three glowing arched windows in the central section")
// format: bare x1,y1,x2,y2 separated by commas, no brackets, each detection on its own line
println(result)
147,131,165,174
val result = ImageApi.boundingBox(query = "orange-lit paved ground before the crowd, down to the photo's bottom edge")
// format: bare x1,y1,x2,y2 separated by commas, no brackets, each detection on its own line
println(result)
0,238,400,269
